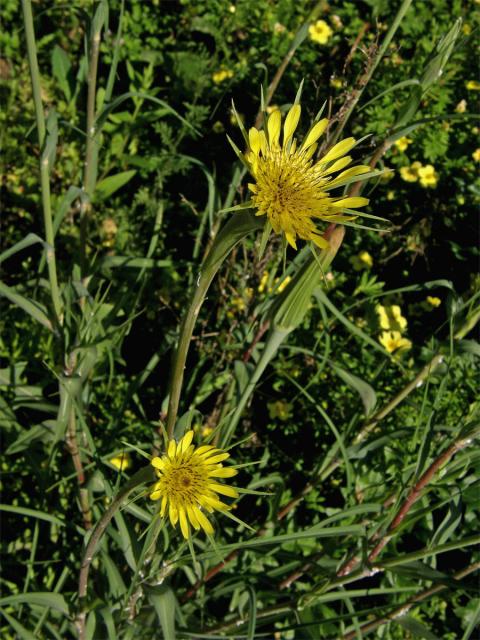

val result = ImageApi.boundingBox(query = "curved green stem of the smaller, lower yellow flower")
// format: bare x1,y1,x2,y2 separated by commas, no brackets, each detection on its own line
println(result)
75,465,155,640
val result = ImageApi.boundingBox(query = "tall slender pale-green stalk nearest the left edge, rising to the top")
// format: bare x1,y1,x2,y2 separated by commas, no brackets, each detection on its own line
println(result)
22,0,63,326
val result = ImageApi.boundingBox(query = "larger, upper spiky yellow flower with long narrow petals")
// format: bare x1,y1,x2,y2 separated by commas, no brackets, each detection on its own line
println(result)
242,104,370,249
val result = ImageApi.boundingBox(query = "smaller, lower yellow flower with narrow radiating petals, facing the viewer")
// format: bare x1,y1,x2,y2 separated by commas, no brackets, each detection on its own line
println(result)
150,431,238,538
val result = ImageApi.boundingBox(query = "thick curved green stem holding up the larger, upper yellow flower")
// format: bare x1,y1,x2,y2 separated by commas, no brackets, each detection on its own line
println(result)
167,212,264,438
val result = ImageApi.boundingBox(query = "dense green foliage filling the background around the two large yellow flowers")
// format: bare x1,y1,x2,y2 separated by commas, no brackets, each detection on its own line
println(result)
0,0,480,640
